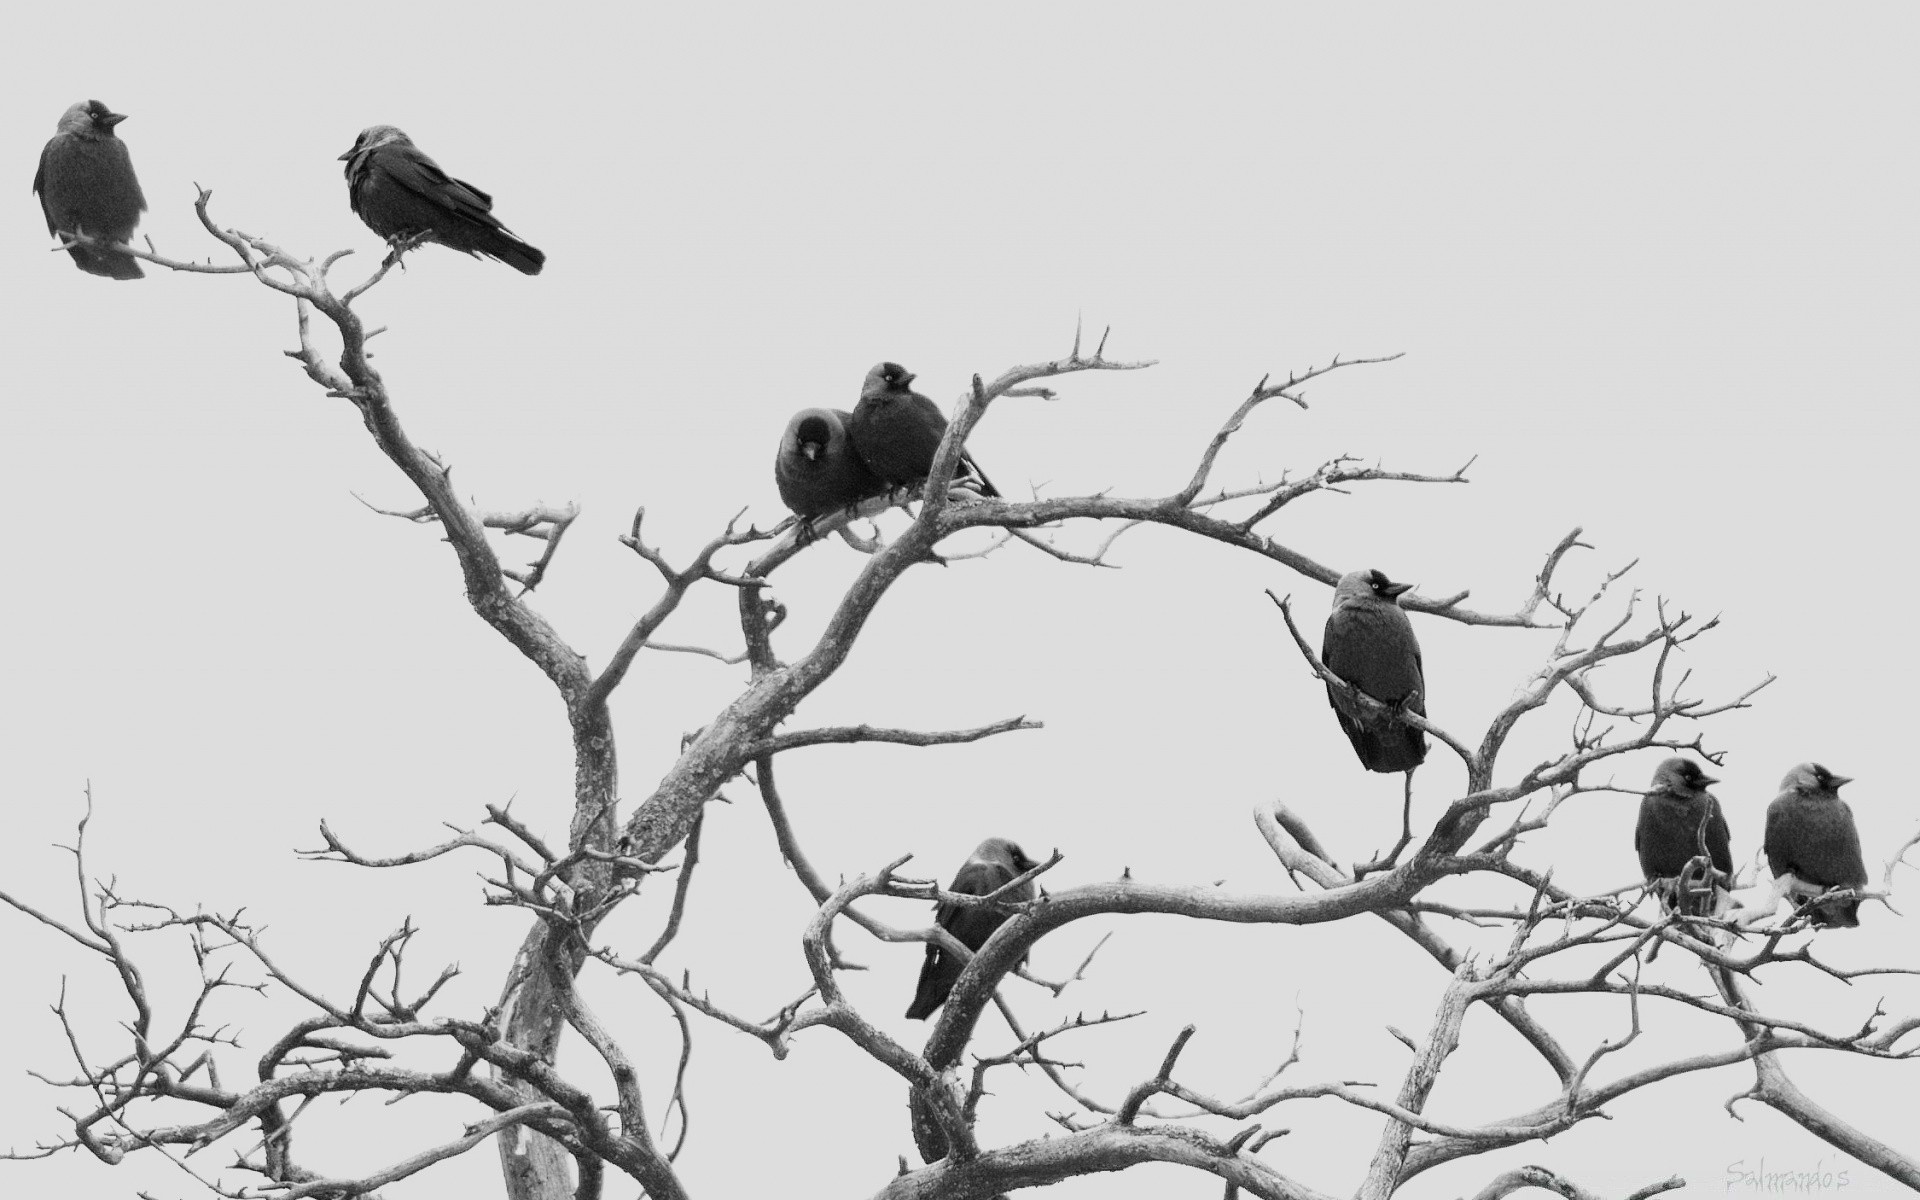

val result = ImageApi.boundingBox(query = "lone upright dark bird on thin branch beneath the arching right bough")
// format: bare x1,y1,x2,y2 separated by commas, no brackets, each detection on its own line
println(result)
1321,570,1427,772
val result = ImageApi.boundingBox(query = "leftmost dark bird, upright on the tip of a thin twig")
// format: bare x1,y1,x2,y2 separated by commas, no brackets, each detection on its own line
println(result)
33,100,146,278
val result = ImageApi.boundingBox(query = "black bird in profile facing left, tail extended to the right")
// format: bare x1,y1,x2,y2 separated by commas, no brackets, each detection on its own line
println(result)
340,125,547,275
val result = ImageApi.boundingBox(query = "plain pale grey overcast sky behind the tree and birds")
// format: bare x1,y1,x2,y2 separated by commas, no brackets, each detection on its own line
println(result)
0,4,1920,1198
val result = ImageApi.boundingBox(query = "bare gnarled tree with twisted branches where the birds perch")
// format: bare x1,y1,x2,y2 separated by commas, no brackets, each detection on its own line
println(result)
0,208,1920,1200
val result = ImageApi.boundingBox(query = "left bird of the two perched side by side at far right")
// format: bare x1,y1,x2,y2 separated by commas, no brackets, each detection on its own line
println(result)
1634,756,1734,916
